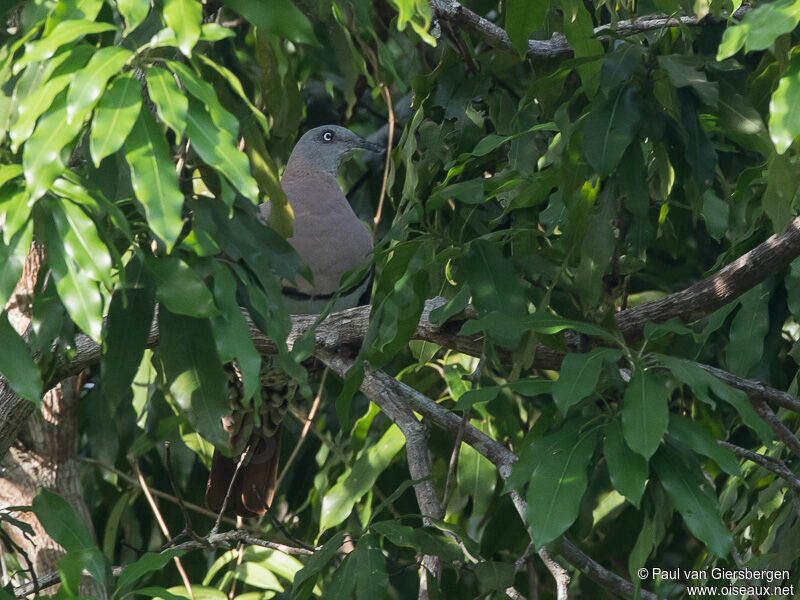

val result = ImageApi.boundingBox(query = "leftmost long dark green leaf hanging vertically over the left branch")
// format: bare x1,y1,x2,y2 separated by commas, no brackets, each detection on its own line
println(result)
100,257,155,399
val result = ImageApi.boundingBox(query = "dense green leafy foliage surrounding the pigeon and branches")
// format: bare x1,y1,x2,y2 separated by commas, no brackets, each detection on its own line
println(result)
0,0,800,600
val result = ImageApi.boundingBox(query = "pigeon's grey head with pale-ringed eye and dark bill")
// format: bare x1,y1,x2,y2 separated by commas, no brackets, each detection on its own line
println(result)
284,125,383,177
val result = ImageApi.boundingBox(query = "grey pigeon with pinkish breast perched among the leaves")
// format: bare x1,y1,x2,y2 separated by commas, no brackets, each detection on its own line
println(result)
206,125,383,517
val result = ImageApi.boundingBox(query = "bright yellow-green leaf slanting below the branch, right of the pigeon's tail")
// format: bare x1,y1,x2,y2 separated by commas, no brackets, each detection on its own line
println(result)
319,425,405,533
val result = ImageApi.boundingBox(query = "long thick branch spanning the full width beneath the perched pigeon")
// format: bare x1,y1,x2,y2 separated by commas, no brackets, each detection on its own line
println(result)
0,212,800,457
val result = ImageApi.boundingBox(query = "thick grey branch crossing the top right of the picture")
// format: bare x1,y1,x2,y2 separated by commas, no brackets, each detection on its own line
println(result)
430,0,750,61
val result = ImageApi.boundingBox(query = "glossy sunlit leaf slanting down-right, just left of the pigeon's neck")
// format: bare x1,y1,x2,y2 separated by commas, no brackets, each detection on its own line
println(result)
186,98,258,203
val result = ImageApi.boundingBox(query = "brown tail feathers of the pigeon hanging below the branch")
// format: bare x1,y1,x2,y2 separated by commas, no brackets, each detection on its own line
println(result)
206,427,280,517
